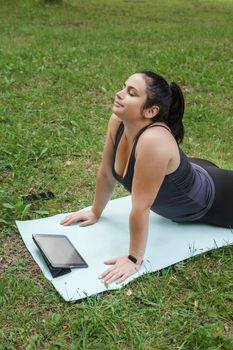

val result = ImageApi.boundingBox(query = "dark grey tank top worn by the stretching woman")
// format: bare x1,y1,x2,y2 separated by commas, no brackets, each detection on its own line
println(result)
112,123,215,222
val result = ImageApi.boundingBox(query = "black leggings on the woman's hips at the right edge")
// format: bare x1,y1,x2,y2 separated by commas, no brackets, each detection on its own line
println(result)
189,158,233,228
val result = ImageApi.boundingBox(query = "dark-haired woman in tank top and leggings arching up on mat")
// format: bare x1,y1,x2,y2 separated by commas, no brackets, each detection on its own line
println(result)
61,71,233,283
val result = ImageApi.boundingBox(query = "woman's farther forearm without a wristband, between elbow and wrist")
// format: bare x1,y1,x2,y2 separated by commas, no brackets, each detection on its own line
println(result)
92,170,116,217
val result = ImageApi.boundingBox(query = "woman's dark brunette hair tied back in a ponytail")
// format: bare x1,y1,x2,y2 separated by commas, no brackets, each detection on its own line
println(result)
139,71,184,144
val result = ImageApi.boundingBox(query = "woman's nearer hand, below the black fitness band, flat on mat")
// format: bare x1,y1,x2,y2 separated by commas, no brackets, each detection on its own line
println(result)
99,256,140,284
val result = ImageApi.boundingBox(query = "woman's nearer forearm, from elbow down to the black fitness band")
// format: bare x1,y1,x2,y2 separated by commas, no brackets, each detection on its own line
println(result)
129,209,150,263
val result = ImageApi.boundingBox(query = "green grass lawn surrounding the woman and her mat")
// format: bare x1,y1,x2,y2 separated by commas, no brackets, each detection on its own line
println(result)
0,0,233,350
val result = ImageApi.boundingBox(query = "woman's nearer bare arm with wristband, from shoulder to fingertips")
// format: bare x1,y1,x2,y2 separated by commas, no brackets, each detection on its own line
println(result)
100,132,172,283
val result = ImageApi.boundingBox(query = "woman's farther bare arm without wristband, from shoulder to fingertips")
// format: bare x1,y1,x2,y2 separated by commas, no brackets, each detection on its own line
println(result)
60,114,120,226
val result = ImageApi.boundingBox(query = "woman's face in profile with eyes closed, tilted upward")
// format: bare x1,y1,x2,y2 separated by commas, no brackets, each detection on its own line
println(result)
112,73,147,120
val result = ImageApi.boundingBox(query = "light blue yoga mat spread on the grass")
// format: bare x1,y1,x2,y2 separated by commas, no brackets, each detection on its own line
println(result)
16,196,233,301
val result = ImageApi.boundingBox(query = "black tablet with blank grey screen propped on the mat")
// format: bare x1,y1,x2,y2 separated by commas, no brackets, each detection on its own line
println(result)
32,234,88,268
